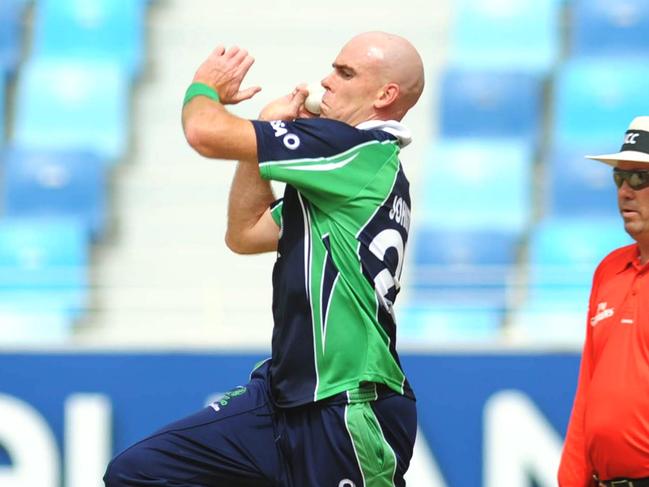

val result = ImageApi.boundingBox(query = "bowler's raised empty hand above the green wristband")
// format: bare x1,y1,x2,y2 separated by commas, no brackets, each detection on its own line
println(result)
194,46,261,105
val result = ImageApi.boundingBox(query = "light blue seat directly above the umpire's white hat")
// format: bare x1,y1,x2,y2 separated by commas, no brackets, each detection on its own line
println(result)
552,58,649,150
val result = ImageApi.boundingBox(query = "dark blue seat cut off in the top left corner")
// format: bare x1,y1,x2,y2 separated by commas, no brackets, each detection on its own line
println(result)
0,0,26,78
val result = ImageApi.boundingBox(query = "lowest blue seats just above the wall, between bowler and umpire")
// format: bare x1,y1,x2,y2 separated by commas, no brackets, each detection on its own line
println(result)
401,217,631,344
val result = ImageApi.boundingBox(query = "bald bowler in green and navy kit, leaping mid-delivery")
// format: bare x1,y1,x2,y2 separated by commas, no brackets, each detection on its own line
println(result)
104,32,424,487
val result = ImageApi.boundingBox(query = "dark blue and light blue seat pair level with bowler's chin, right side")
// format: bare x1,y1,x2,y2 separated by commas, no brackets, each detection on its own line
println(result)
439,58,649,148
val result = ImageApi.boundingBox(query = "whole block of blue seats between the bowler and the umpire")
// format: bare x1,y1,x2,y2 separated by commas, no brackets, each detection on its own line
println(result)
402,0,649,343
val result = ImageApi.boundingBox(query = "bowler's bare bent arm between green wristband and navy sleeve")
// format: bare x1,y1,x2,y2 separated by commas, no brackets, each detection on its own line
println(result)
182,96,257,161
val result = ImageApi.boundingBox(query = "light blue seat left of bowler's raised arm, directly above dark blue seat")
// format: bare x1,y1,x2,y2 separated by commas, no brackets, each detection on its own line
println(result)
13,60,129,163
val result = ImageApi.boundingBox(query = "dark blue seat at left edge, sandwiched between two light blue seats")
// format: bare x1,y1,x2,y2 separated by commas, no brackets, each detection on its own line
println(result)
2,149,106,239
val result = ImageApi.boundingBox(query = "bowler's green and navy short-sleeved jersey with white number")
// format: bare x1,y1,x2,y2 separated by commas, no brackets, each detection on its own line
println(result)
253,119,412,407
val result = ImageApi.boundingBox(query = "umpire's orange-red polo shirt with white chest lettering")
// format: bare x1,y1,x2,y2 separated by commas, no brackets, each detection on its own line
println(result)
559,244,649,487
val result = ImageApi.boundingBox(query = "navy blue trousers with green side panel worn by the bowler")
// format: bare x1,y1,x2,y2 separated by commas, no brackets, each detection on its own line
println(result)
104,363,417,487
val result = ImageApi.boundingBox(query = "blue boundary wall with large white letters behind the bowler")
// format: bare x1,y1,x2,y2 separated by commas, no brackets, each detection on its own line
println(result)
0,351,579,487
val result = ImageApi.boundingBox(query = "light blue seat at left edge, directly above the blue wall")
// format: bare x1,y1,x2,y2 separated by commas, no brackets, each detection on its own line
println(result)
0,217,89,343
